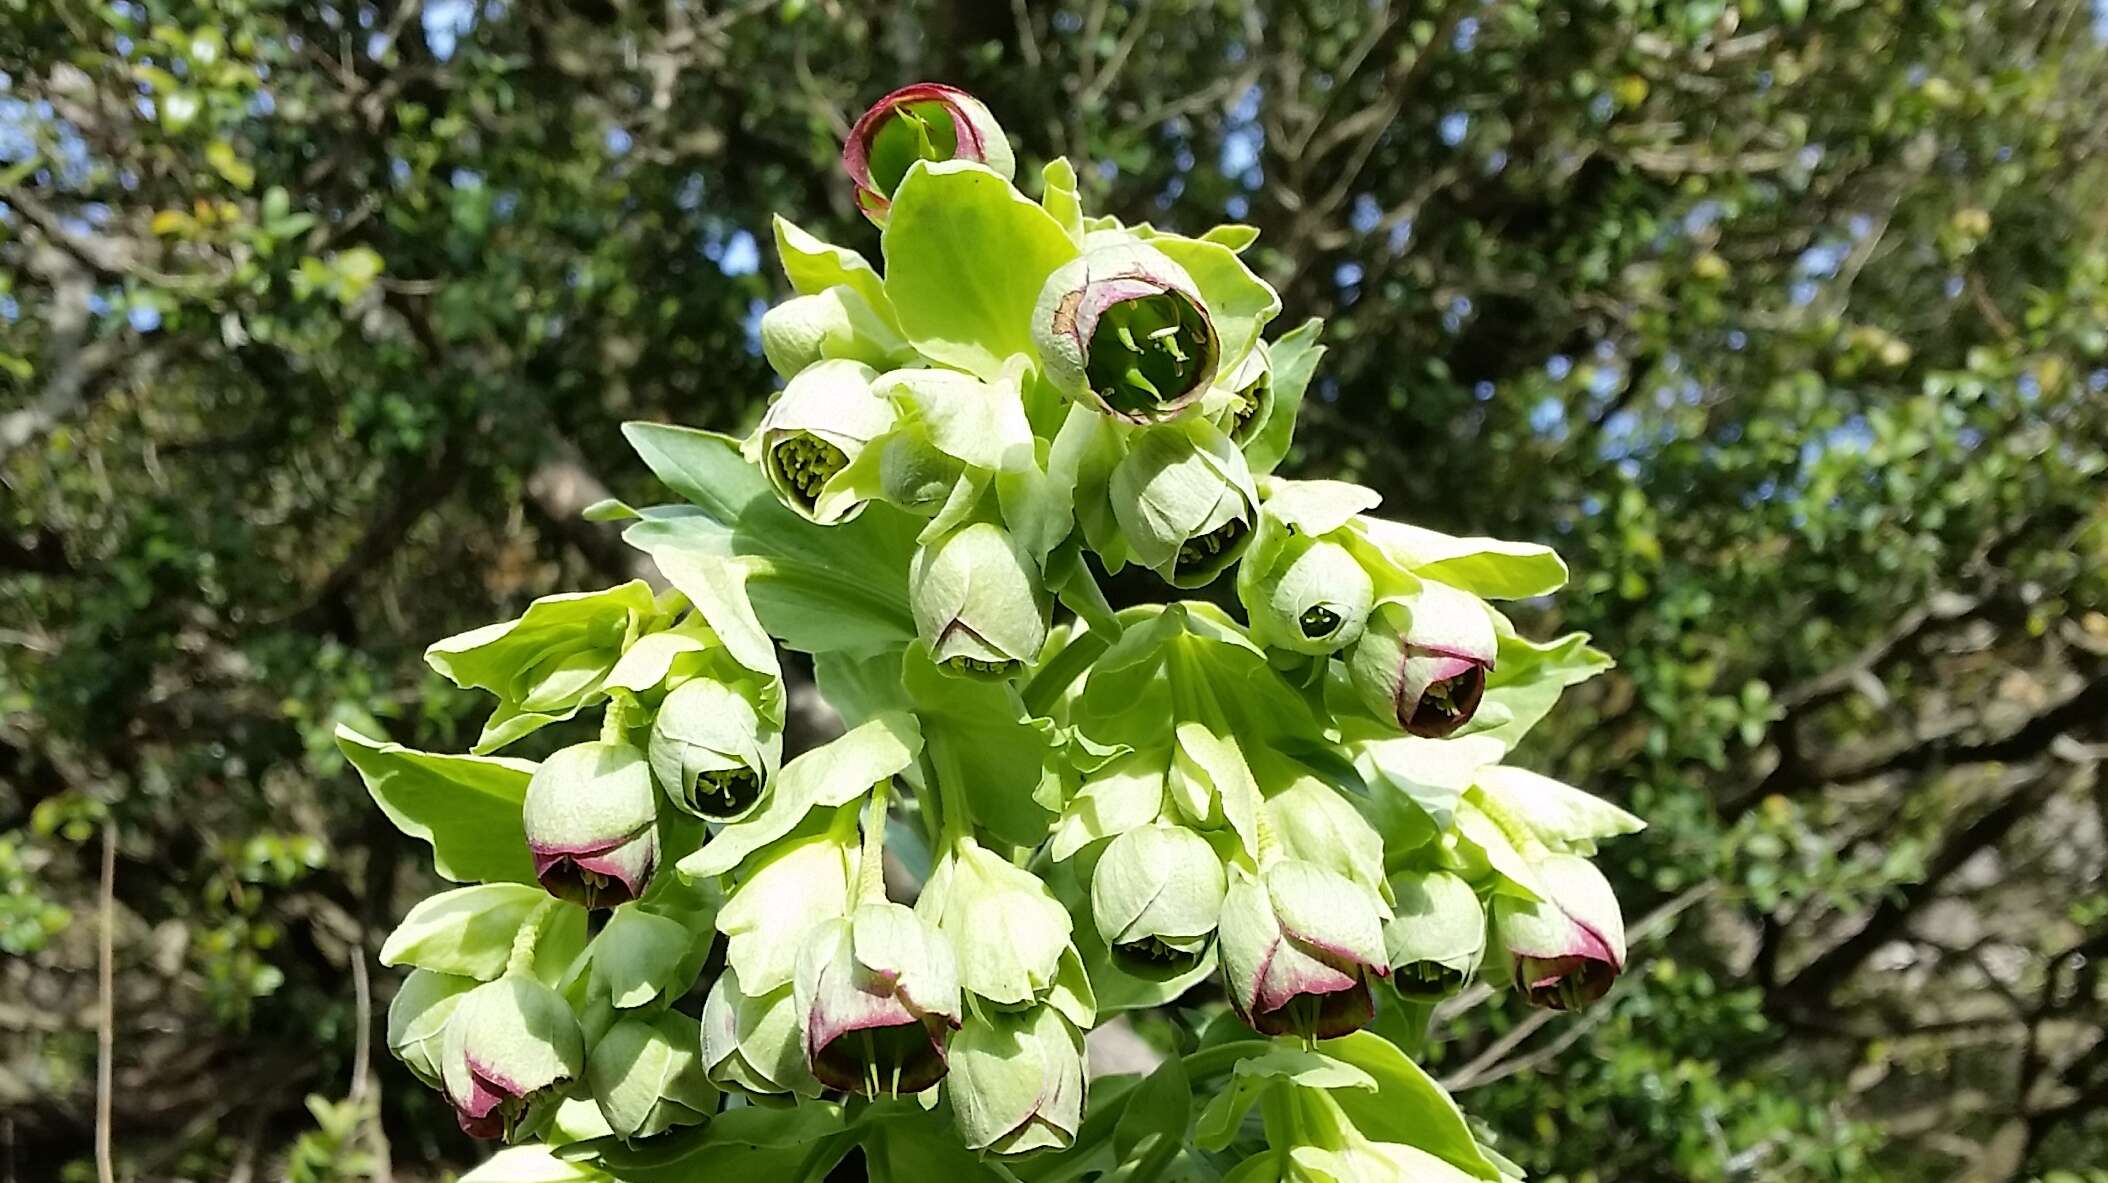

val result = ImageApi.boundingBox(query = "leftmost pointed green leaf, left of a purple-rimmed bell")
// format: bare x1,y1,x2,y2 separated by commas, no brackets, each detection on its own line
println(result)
337,723,535,884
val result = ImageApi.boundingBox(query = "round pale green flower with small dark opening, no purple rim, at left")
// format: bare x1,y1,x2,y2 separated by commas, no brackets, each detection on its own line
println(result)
649,677,782,822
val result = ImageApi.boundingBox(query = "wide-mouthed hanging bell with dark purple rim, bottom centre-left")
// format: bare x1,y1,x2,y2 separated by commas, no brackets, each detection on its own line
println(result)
795,903,959,1097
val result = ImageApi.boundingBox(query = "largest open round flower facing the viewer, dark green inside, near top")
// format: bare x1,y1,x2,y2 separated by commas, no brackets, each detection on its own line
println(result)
1033,240,1221,424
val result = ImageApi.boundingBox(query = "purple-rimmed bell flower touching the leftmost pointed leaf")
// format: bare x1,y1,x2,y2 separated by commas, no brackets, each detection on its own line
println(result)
521,742,658,909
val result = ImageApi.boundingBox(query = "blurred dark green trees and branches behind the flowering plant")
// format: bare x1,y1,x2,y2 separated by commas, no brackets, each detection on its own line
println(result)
0,0,2108,1179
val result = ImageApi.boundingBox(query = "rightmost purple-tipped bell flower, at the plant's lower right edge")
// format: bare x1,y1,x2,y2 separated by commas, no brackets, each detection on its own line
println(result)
1492,854,1625,1010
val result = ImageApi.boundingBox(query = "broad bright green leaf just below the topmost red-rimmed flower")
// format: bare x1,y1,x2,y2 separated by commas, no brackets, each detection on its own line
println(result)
883,160,1077,380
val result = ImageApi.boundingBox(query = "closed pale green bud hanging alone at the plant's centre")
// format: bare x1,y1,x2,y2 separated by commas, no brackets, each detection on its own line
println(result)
909,521,1050,679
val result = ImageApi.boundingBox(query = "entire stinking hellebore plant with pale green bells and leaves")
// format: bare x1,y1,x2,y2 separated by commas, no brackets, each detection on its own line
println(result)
354,84,1640,1183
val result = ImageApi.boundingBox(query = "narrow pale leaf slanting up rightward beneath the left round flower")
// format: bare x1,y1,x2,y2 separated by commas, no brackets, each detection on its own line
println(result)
679,713,923,879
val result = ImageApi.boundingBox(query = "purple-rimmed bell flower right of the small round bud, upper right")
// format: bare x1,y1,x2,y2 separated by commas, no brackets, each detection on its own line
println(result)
1347,582,1497,740
